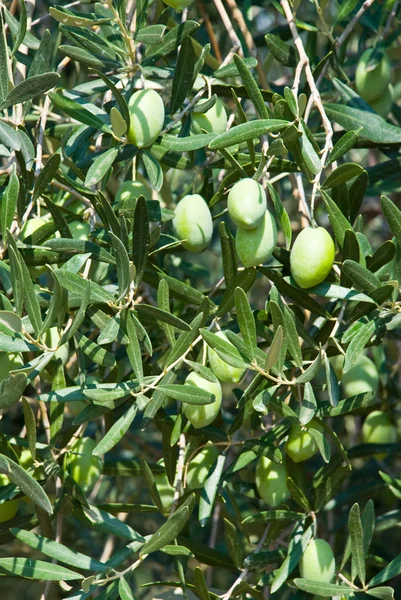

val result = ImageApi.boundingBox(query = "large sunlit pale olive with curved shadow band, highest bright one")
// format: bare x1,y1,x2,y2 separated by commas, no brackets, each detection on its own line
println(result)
127,90,164,148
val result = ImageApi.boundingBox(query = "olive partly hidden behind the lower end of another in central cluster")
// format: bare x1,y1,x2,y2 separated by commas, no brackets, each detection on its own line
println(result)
235,210,277,268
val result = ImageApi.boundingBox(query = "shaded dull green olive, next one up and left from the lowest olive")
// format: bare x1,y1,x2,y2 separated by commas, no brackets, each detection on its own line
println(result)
256,456,290,507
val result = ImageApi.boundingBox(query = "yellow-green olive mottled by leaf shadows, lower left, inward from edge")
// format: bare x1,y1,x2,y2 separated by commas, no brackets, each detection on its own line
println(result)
65,437,103,491
